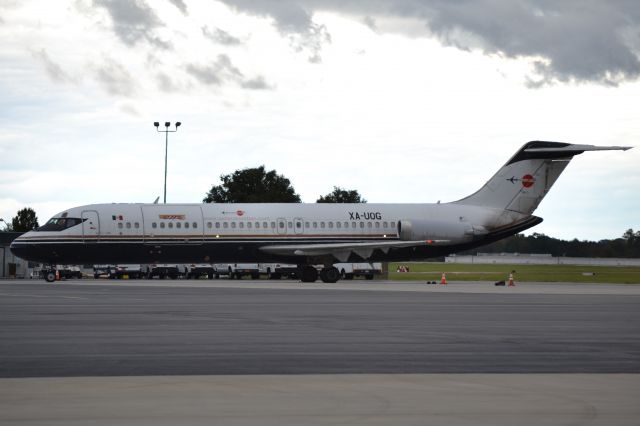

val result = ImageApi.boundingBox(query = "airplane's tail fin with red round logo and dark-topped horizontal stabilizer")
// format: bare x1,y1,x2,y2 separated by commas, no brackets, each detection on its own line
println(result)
454,141,630,215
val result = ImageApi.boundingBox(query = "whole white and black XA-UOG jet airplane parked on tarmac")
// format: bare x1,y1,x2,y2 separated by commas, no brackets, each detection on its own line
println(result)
11,141,630,282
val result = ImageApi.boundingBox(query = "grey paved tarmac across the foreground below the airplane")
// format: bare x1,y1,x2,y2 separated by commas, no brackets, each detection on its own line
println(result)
0,280,640,424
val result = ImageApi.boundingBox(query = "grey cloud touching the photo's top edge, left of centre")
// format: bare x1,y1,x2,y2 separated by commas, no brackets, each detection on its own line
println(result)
94,0,171,50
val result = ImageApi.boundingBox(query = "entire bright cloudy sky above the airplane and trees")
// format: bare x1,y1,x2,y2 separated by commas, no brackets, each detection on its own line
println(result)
0,0,640,240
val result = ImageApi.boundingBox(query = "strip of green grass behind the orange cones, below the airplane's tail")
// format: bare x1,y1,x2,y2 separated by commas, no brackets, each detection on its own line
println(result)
389,262,640,284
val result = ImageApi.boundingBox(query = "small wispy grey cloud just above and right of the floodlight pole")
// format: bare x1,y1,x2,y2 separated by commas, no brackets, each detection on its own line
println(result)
186,54,272,90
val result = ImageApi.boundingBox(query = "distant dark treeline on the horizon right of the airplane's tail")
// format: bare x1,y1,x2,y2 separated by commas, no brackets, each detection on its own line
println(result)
460,229,640,257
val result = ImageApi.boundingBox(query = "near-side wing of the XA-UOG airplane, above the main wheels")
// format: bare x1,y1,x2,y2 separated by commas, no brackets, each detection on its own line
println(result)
260,240,449,262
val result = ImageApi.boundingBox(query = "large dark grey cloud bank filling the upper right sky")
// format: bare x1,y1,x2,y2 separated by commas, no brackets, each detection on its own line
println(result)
216,0,640,87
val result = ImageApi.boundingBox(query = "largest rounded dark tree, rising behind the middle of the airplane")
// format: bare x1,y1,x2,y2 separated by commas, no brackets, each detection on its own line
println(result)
202,165,300,203
